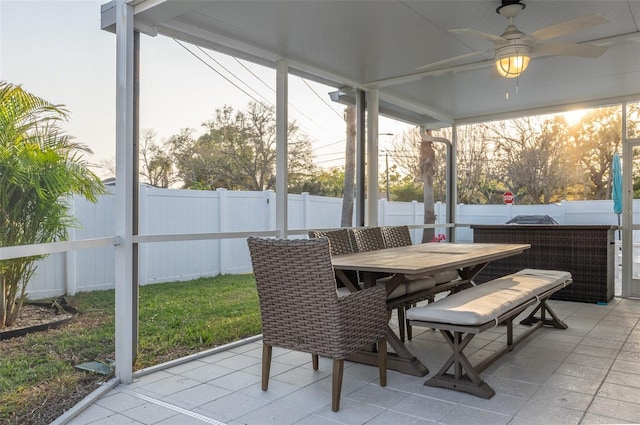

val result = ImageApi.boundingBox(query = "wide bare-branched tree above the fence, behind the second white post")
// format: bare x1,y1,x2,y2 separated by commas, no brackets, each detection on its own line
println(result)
169,102,315,190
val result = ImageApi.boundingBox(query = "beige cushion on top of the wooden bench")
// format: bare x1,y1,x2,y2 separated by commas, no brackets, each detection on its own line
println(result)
407,269,571,326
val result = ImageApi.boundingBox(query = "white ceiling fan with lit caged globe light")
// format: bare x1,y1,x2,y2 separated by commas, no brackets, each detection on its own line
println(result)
418,0,609,78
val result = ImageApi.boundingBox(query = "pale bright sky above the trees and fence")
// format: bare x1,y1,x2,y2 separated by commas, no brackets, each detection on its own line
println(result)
0,0,407,176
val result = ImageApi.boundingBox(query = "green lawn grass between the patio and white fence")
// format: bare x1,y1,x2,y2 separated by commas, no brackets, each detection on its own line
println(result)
0,275,261,424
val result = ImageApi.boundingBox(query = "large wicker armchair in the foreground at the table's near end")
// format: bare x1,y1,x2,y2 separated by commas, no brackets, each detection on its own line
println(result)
247,237,387,412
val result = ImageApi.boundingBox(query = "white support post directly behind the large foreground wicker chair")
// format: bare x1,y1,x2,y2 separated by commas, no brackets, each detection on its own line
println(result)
276,61,289,239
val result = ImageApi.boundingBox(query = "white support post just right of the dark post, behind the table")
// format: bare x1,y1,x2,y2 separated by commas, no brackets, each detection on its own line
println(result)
365,89,380,226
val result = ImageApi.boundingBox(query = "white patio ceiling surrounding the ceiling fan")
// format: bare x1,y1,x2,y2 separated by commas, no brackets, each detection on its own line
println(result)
102,0,640,127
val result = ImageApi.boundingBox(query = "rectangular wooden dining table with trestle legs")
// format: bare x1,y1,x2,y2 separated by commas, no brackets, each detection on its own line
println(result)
332,243,531,376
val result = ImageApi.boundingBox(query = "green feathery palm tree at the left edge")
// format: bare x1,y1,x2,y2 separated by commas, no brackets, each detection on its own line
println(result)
0,81,105,329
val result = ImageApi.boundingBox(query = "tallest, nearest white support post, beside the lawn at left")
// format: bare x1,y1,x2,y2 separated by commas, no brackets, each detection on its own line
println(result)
115,0,137,384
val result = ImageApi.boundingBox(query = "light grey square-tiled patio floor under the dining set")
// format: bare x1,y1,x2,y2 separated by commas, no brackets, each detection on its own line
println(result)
64,298,640,425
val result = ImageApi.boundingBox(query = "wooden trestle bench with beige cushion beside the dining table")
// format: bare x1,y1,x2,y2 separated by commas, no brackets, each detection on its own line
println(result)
407,269,572,399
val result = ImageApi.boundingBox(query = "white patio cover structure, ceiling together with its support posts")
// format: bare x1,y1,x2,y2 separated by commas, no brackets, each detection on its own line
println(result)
101,0,640,383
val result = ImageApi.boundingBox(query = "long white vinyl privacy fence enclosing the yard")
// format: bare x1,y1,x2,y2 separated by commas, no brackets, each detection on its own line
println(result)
28,185,624,299
